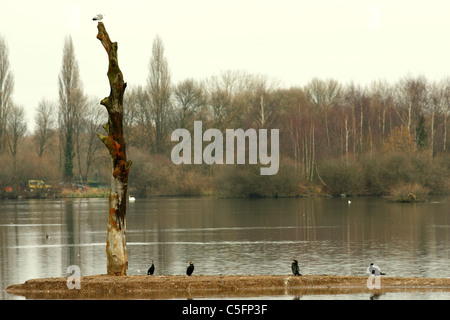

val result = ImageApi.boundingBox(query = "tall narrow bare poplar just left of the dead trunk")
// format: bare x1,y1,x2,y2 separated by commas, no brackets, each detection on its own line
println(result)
59,36,85,181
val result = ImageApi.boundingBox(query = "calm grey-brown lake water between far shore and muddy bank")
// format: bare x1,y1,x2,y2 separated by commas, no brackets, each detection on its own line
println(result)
0,197,450,299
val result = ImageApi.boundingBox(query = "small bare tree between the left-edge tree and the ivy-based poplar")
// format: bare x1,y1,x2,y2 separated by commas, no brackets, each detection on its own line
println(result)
33,99,55,158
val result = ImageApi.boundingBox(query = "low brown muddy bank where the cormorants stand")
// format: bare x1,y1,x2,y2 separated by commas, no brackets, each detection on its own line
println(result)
5,275,450,299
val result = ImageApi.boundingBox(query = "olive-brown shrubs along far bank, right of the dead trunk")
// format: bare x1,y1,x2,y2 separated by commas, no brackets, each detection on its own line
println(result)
129,153,450,199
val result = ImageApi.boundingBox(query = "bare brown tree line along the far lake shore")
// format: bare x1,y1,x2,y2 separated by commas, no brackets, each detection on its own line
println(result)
0,36,450,197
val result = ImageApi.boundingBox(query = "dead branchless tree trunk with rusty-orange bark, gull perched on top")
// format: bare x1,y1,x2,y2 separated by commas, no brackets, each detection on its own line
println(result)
97,22,131,276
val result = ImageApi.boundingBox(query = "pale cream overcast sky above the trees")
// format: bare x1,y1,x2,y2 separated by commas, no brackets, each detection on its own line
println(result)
0,0,450,129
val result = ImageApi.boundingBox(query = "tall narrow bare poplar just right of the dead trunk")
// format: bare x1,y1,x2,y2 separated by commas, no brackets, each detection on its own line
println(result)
148,36,171,153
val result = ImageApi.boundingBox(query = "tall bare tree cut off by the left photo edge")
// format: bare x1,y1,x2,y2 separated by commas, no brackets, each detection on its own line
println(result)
0,35,14,152
